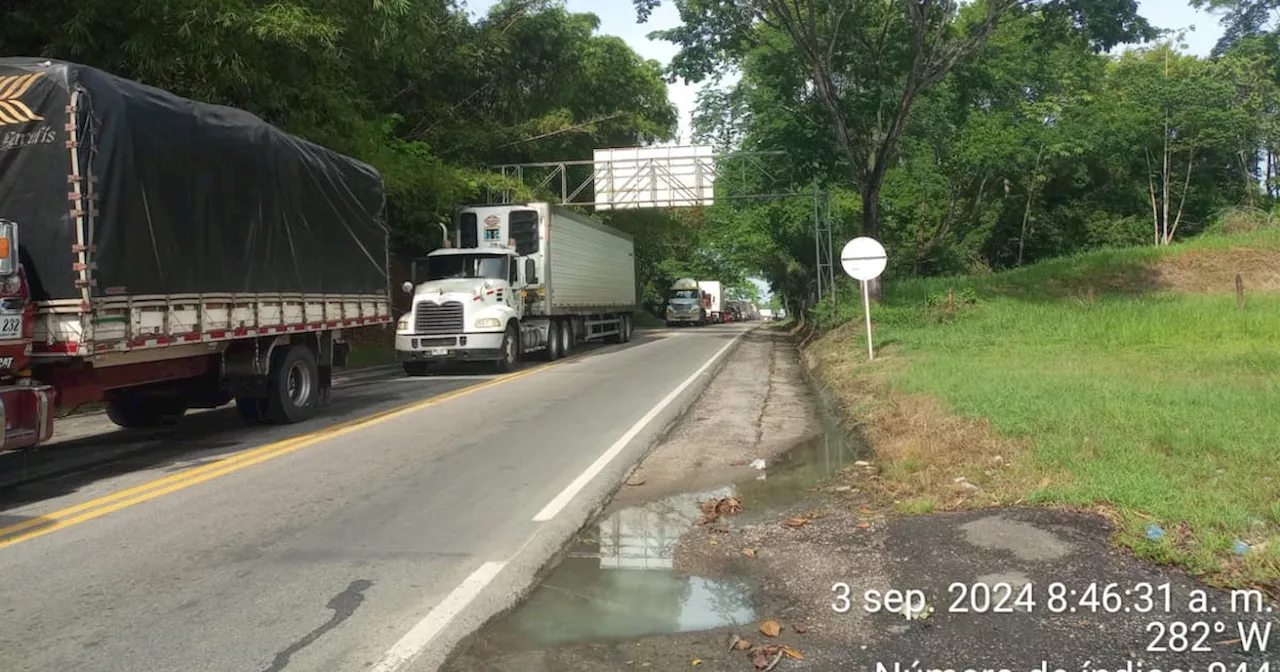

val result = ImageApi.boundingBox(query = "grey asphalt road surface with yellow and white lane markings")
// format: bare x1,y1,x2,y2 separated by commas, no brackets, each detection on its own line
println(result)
0,325,744,672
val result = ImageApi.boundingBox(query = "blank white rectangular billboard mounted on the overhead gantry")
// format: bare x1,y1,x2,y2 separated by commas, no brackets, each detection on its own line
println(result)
594,145,716,210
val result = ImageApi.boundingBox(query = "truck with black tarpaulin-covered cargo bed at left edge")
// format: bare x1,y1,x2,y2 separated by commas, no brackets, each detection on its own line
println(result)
0,58,392,451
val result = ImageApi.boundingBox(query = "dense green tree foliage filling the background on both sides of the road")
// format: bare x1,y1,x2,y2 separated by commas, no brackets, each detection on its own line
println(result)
0,0,1280,316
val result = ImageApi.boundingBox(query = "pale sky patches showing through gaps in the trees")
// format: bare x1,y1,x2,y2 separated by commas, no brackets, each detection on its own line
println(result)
465,0,1222,298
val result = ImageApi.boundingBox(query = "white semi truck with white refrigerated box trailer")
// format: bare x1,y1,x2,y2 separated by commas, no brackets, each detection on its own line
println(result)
396,202,639,376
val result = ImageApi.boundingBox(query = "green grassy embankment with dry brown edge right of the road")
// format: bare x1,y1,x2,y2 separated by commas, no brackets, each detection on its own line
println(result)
808,230,1280,586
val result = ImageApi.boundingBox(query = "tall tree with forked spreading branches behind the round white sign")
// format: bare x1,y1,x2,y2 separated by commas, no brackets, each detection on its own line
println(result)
635,0,1153,295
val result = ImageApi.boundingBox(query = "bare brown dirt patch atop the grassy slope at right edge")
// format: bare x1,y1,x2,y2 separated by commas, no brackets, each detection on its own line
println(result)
1156,247,1280,293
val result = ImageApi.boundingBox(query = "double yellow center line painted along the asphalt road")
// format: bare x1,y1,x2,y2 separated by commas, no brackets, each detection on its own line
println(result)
0,364,545,548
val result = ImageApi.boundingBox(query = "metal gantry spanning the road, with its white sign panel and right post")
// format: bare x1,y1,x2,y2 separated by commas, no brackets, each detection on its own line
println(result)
485,146,836,305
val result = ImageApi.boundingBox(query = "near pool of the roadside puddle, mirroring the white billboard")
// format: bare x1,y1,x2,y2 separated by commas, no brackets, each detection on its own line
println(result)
490,488,755,644
